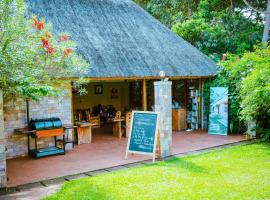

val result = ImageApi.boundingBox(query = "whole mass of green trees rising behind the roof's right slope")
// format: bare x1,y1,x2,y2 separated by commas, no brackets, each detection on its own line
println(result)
136,0,266,58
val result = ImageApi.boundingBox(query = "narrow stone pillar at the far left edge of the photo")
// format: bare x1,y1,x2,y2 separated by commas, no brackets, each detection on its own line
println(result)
0,91,7,188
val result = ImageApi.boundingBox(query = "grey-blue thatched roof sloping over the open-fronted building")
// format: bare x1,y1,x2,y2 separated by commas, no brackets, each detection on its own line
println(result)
27,0,216,77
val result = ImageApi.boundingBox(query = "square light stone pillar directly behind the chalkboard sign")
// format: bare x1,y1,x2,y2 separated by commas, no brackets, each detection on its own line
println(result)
154,81,172,157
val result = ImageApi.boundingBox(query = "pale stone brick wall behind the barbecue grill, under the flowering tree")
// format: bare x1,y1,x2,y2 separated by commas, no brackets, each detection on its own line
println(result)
4,92,72,158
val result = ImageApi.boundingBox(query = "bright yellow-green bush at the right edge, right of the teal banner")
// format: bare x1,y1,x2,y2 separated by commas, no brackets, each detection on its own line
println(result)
238,47,270,140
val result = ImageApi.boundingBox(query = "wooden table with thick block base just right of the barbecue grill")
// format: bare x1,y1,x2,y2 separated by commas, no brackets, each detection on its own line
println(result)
76,122,95,144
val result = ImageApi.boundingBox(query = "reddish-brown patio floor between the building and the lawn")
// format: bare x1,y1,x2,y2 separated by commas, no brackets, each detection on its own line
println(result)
7,126,245,186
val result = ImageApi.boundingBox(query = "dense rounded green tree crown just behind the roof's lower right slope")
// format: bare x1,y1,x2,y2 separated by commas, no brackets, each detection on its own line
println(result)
172,0,263,61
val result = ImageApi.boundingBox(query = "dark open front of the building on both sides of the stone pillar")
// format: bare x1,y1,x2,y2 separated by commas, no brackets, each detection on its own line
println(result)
72,79,202,145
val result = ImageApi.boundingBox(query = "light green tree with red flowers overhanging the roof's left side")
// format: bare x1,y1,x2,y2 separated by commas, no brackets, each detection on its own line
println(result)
0,0,89,99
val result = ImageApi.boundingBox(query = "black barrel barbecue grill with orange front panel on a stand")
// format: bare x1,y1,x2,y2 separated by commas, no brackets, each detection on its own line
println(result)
17,118,68,158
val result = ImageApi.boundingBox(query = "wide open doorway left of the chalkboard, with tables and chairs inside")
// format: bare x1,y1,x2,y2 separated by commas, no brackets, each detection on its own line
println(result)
72,81,136,144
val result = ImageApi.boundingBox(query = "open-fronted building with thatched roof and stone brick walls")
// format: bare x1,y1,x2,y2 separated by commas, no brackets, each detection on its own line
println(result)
0,0,216,186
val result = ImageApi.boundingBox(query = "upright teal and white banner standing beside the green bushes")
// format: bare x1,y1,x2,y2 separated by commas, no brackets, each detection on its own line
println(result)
208,87,228,135
